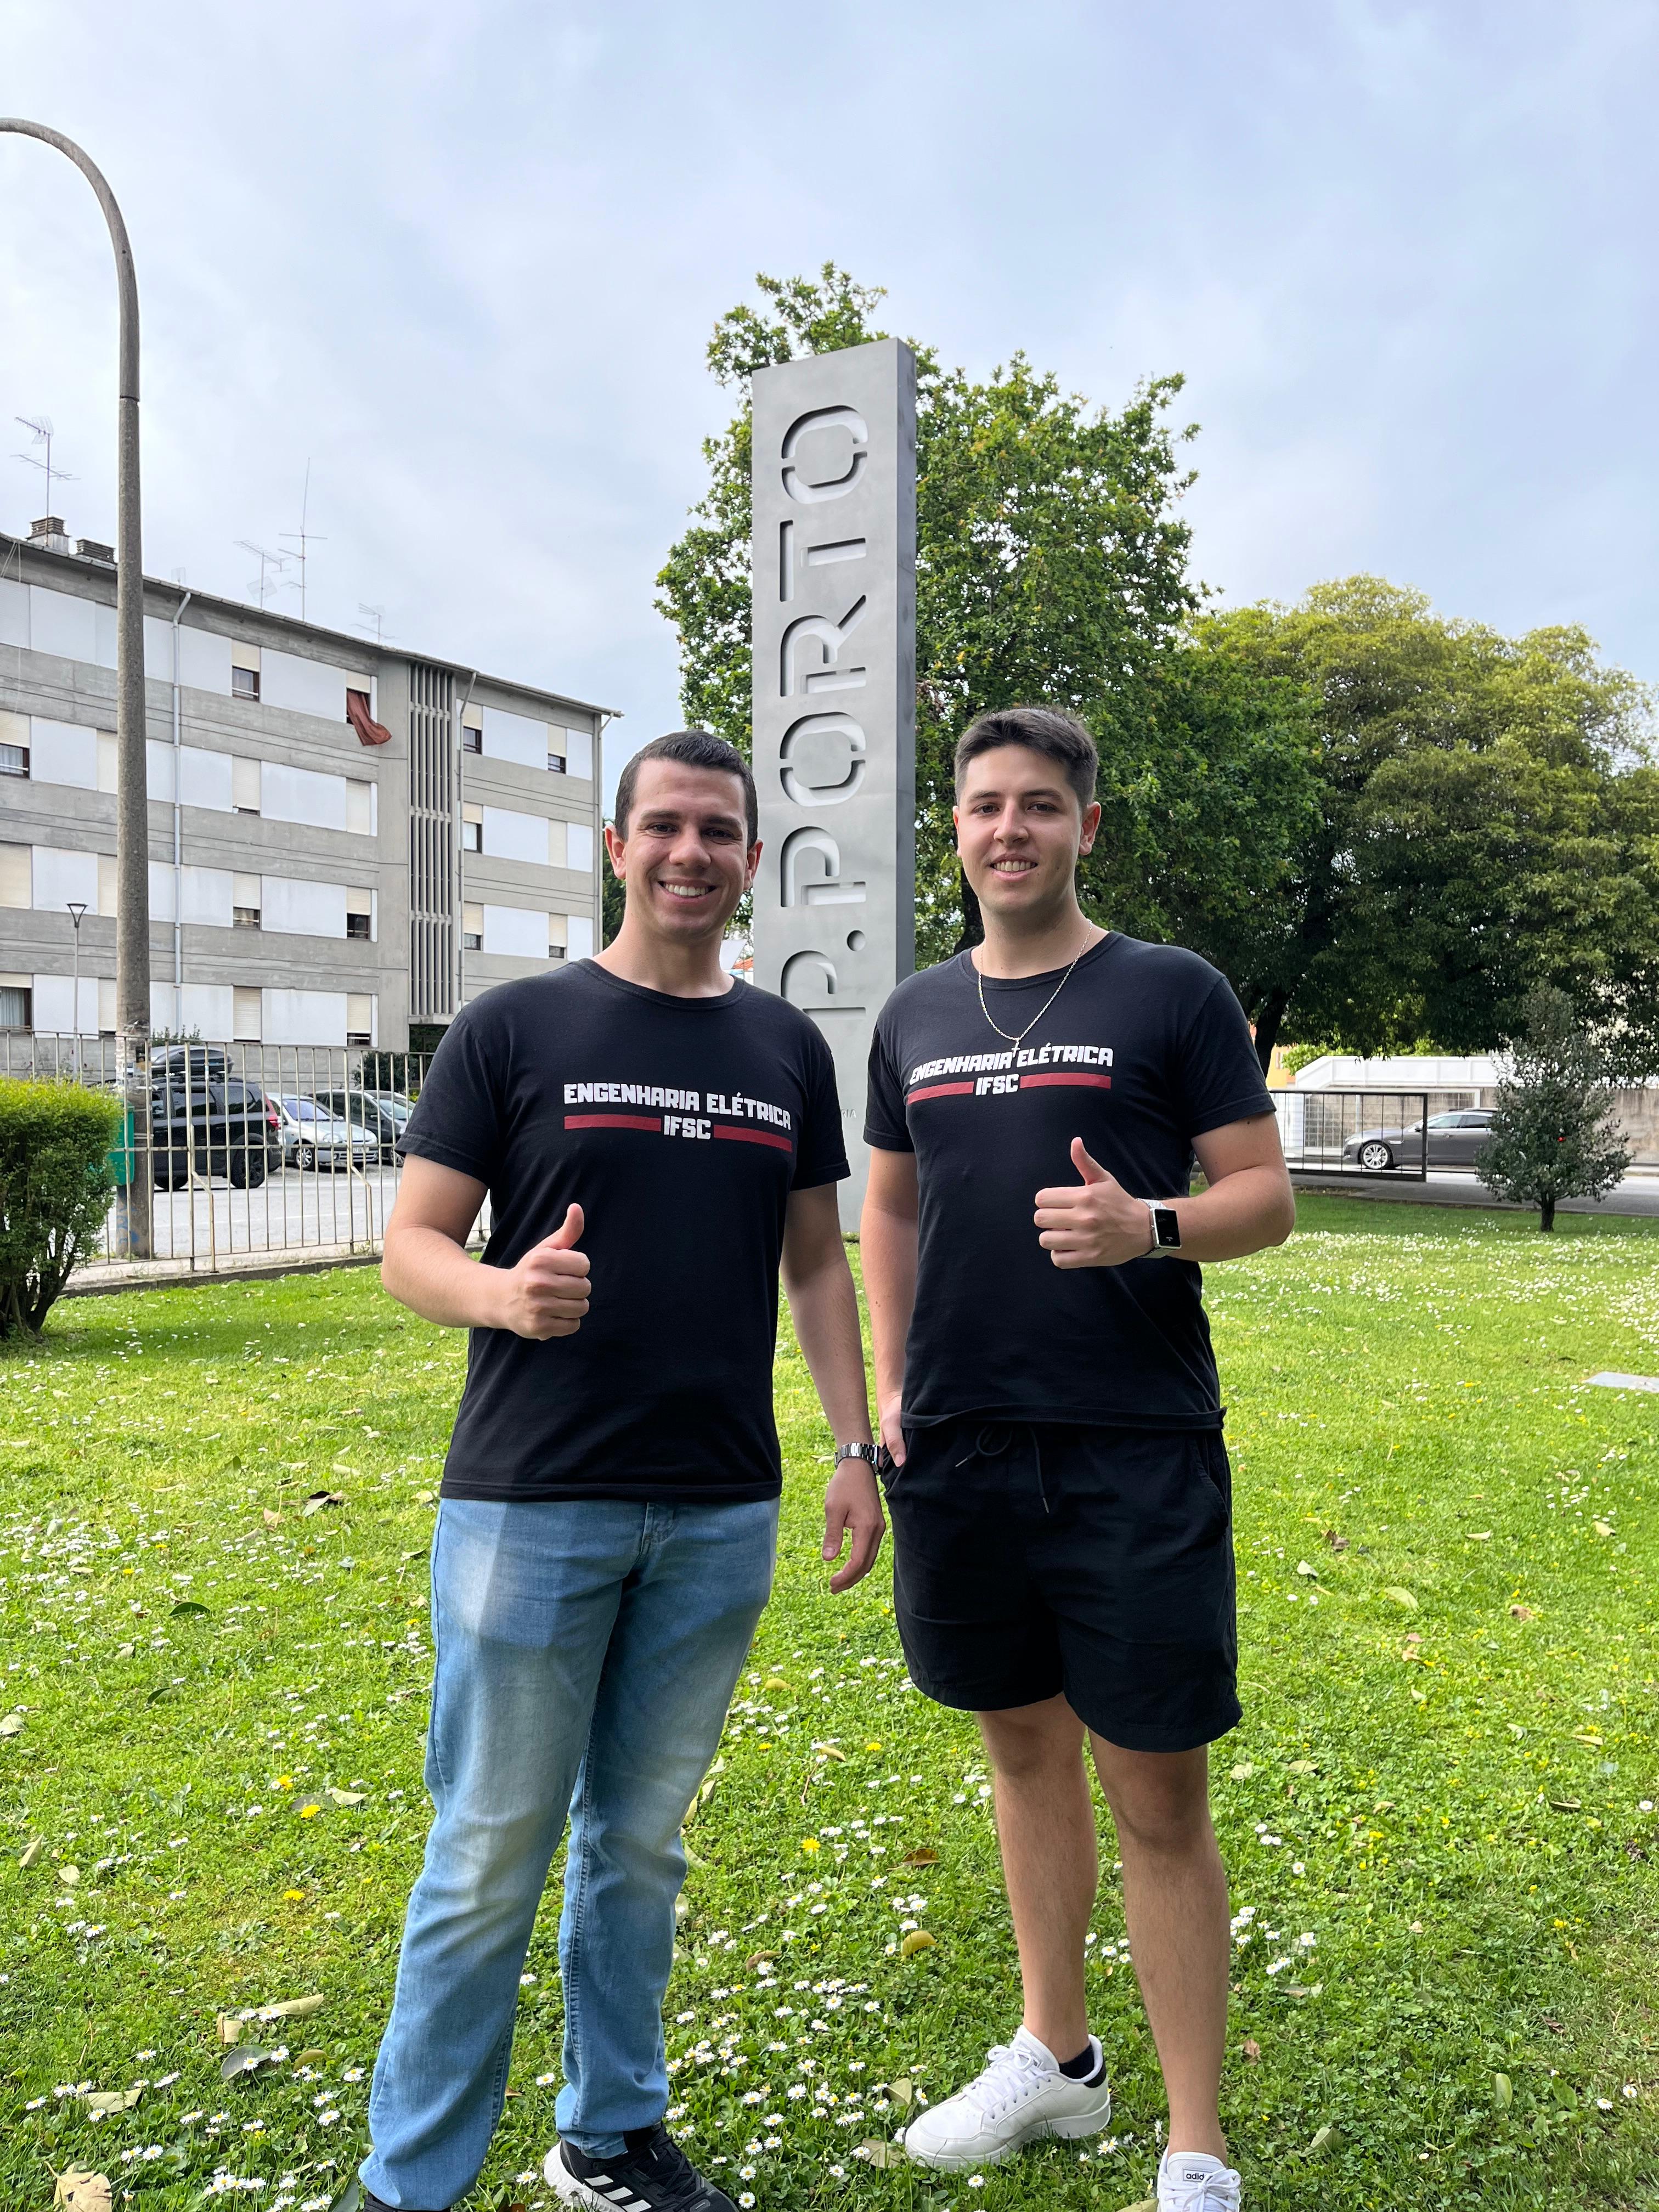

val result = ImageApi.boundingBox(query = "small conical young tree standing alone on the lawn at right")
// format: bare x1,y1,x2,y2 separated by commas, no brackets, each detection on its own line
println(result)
1475,986,1630,1230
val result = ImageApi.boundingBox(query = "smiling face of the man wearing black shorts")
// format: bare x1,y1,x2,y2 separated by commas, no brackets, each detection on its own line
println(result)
956,746,1099,922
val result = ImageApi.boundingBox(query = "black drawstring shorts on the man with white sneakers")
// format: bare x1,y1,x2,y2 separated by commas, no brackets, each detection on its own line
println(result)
885,1413,1243,1752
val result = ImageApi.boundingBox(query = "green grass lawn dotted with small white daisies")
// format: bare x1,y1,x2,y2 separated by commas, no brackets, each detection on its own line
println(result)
0,1197,1659,2212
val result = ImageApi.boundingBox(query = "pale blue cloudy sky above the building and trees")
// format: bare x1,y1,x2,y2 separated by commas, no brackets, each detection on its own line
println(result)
0,0,1659,805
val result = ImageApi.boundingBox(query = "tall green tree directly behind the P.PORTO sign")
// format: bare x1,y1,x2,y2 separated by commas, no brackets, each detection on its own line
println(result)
657,263,1312,964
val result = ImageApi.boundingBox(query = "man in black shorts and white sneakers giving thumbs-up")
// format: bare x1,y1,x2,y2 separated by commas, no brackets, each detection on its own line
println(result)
862,708,1294,2212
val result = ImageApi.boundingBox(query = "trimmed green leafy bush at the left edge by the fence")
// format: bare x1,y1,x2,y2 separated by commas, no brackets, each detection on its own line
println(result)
0,1080,122,1336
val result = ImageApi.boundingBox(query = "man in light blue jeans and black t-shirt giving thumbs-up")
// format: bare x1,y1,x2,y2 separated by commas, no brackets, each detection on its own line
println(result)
363,730,883,2212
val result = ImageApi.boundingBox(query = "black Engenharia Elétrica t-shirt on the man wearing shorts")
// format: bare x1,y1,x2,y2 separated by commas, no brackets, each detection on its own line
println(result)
865,934,1272,1429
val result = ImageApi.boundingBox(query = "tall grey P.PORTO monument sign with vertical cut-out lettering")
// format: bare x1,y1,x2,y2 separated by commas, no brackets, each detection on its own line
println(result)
754,338,916,1226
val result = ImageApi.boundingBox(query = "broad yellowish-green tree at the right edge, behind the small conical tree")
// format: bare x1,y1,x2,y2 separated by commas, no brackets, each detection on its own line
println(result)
1197,577,1659,1066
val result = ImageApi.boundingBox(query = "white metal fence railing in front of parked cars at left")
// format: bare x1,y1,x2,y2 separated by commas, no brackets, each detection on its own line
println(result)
0,1031,489,1276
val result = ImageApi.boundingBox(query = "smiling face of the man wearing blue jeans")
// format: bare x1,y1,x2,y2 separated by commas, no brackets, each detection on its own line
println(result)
604,761,761,945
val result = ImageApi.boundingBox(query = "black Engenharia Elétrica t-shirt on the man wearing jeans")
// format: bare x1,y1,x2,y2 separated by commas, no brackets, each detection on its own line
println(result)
398,960,847,1504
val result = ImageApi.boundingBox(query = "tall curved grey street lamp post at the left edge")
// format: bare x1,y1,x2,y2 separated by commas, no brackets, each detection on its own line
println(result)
0,115,150,1259
